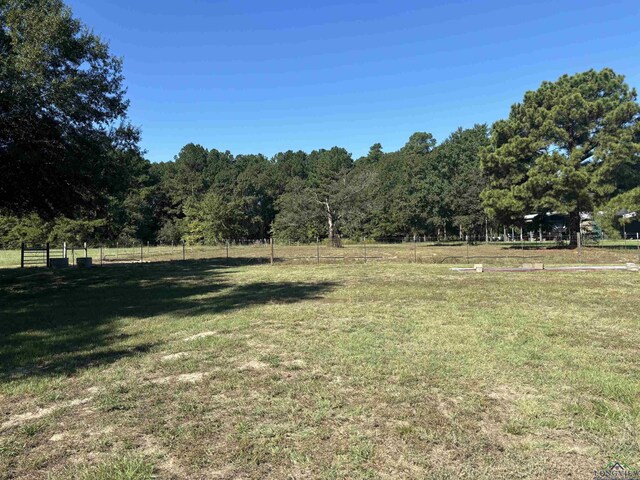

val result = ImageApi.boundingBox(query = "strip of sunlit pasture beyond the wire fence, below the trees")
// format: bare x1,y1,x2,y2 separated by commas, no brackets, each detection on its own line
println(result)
0,240,640,268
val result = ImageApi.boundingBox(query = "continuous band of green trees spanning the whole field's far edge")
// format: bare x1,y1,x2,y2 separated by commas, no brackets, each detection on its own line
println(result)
0,0,640,246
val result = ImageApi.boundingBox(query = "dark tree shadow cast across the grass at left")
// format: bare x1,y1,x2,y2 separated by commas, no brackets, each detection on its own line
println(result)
0,259,336,381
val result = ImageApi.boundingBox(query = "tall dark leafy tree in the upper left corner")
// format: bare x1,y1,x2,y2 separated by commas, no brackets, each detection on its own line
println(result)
0,0,139,218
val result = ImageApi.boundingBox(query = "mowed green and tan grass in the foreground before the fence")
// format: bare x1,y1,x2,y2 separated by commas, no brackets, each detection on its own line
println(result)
0,261,640,479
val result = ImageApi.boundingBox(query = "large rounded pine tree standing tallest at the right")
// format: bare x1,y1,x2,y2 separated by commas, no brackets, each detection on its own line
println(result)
482,68,640,238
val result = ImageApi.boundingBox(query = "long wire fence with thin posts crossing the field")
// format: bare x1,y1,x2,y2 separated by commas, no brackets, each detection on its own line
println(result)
5,235,640,268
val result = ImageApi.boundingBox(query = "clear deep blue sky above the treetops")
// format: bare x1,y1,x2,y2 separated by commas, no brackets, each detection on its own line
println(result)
67,0,640,161
